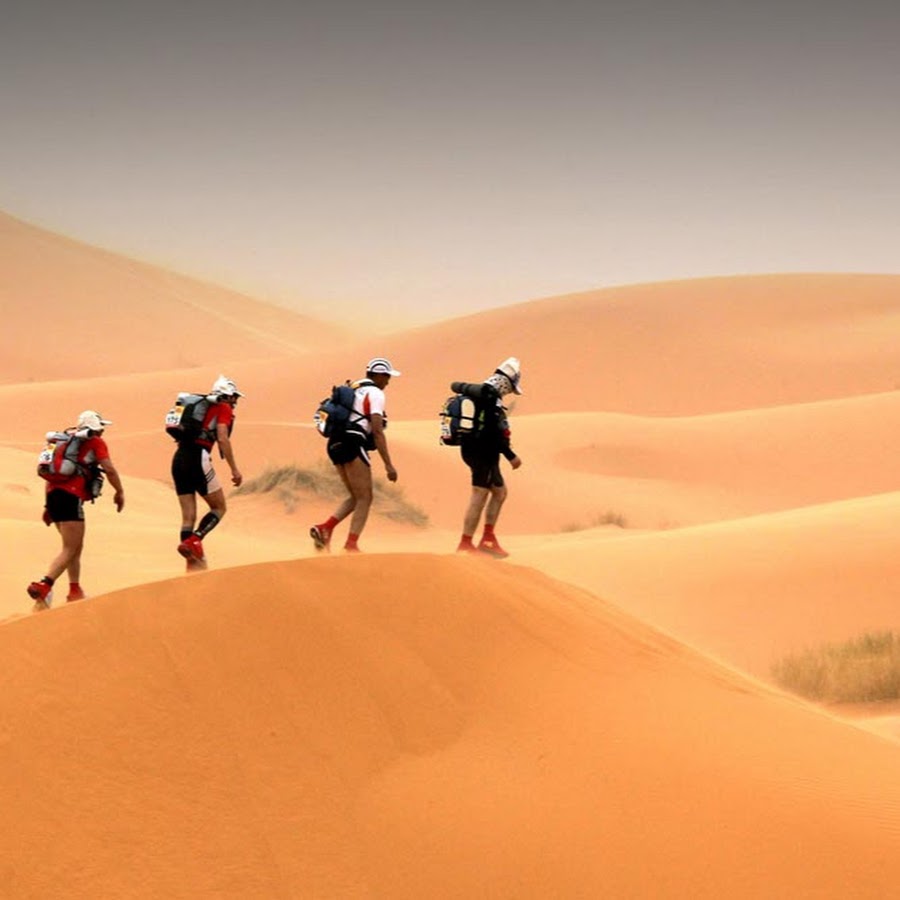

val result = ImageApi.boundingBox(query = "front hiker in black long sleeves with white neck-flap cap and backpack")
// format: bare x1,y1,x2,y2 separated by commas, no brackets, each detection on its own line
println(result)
441,356,522,559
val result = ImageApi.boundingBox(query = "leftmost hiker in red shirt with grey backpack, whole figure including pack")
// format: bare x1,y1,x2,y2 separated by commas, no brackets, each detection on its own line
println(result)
26,409,125,612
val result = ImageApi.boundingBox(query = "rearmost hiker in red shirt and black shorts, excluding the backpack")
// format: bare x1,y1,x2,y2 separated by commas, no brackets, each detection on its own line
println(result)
26,409,125,612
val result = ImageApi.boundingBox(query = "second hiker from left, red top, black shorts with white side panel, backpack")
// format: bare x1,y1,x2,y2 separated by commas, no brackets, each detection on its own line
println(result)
166,375,244,572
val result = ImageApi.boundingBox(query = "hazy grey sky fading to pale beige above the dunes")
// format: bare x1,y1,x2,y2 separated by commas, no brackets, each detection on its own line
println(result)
0,0,900,325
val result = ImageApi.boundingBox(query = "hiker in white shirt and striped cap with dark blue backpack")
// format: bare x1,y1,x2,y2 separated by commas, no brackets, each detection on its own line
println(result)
309,357,400,553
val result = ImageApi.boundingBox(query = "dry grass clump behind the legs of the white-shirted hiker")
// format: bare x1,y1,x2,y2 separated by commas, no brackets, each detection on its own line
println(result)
234,463,428,528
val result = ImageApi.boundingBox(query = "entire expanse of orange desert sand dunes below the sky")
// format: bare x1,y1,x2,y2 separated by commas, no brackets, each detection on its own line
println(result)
0,216,900,898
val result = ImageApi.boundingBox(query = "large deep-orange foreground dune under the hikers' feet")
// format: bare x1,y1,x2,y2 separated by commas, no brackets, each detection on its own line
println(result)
0,556,900,900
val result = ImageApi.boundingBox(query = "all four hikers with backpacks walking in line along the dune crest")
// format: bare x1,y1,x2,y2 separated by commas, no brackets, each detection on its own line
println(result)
26,356,522,611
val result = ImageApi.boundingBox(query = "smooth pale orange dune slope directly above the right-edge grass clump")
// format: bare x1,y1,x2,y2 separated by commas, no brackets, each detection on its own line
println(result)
528,493,900,676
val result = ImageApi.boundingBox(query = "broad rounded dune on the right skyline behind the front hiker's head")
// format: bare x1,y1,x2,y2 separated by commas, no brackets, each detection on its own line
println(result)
360,274,900,418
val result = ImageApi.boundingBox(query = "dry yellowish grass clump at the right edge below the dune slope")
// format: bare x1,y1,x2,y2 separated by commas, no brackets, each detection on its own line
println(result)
772,631,900,703
